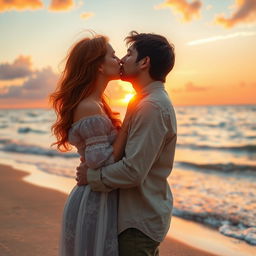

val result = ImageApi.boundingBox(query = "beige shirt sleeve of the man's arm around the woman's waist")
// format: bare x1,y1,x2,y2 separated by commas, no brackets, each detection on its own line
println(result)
87,102,168,191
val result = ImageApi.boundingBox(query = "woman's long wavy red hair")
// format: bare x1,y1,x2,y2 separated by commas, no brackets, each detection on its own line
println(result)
50,36,121,151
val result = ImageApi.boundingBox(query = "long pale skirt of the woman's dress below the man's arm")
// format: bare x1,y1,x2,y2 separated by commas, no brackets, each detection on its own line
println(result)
60,185,118,256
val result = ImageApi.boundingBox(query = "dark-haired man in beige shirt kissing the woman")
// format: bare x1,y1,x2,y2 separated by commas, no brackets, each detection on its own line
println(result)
77,31,177,256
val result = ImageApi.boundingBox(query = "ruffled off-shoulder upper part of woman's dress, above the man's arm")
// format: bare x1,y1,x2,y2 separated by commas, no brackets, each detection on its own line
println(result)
68,115,116,169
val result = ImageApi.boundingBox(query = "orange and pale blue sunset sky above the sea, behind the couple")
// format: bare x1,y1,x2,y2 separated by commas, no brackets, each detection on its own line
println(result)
0,0,256,108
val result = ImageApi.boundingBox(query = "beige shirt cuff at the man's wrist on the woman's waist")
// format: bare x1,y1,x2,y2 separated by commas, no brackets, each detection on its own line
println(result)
87,168,113,192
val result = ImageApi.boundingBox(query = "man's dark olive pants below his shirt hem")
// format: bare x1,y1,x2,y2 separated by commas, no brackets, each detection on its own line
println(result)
118,228,160,256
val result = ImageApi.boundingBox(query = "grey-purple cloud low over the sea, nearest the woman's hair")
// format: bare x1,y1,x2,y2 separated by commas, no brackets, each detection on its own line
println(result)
0,67,58,100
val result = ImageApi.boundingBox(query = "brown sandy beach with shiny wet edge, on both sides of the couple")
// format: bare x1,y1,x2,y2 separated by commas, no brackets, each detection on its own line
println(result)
0,164,256,256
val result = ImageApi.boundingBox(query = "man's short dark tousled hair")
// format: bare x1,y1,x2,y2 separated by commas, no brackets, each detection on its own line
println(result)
125,31,175,82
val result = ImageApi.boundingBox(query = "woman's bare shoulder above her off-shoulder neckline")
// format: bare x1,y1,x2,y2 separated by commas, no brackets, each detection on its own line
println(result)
73,99,102,122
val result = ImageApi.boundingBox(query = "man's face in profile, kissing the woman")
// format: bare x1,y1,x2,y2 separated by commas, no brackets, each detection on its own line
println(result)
120,46,140,82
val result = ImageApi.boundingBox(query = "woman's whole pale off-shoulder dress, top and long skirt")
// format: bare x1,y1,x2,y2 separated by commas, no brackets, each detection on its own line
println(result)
60,115,118,256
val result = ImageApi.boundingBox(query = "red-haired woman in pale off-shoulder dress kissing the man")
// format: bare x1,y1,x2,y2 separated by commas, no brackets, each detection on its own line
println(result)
51,36,130,256
